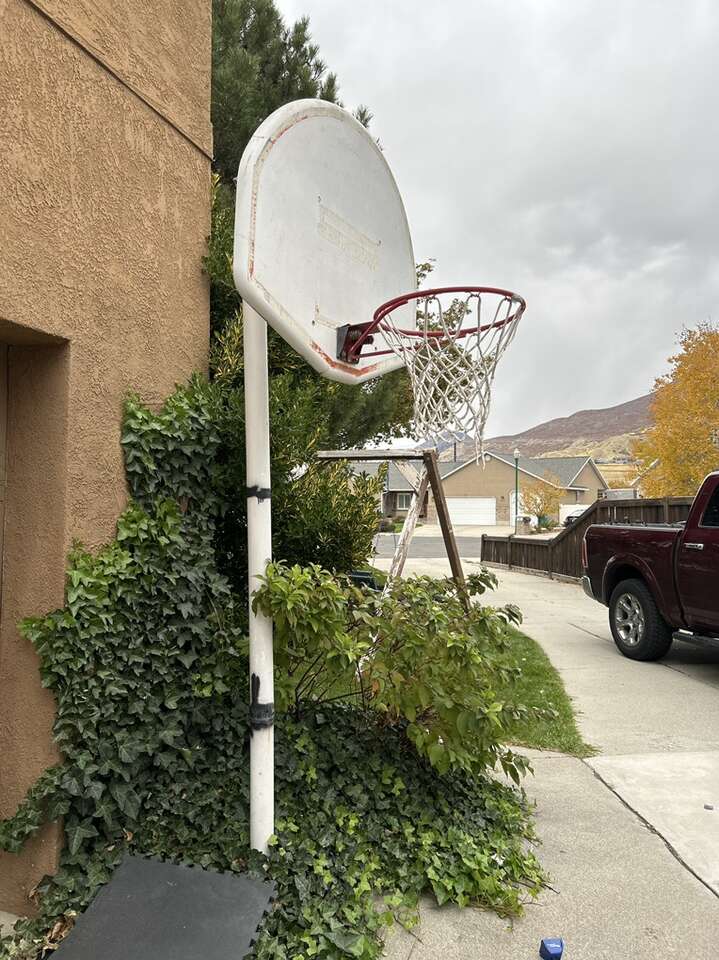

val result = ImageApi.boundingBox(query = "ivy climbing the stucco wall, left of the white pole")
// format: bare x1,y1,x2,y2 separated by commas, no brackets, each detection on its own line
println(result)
0,378,246,952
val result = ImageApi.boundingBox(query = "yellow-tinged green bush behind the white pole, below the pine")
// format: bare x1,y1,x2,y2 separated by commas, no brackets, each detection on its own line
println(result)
213,321,384,602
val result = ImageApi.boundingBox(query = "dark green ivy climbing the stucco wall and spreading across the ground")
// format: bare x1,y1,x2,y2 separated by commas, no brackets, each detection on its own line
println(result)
0,378,542,960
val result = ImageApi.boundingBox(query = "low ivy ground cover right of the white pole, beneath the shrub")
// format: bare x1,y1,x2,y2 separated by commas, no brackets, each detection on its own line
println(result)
255,704,543,960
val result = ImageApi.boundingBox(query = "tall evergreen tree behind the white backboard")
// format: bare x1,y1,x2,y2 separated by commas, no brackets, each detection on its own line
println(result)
207,0,412,447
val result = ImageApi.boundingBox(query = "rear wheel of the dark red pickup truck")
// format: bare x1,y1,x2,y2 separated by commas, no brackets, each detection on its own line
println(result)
609,580,672,660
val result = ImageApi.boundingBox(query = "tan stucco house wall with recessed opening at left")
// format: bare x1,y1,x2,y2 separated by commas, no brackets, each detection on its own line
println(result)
0,0,210,912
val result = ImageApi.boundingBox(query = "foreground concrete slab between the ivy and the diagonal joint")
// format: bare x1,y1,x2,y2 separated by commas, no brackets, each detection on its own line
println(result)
386,751,719,960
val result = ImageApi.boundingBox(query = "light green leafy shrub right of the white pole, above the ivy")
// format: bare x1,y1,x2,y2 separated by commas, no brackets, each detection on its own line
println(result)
254,563,527,782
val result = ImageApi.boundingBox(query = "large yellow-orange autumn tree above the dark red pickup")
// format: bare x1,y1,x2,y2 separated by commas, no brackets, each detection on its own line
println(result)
633,323,719,497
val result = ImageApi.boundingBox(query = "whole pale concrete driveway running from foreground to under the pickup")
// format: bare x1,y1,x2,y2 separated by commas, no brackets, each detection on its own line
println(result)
378,560,719,960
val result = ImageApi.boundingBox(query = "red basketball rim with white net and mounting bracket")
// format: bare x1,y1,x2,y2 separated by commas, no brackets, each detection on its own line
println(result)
338,287,526,460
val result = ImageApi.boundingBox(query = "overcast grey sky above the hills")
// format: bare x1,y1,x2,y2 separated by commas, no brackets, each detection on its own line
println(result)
278,0,719,436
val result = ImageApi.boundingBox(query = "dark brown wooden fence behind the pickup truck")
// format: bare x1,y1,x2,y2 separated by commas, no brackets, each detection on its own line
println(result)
482,497,692,580
